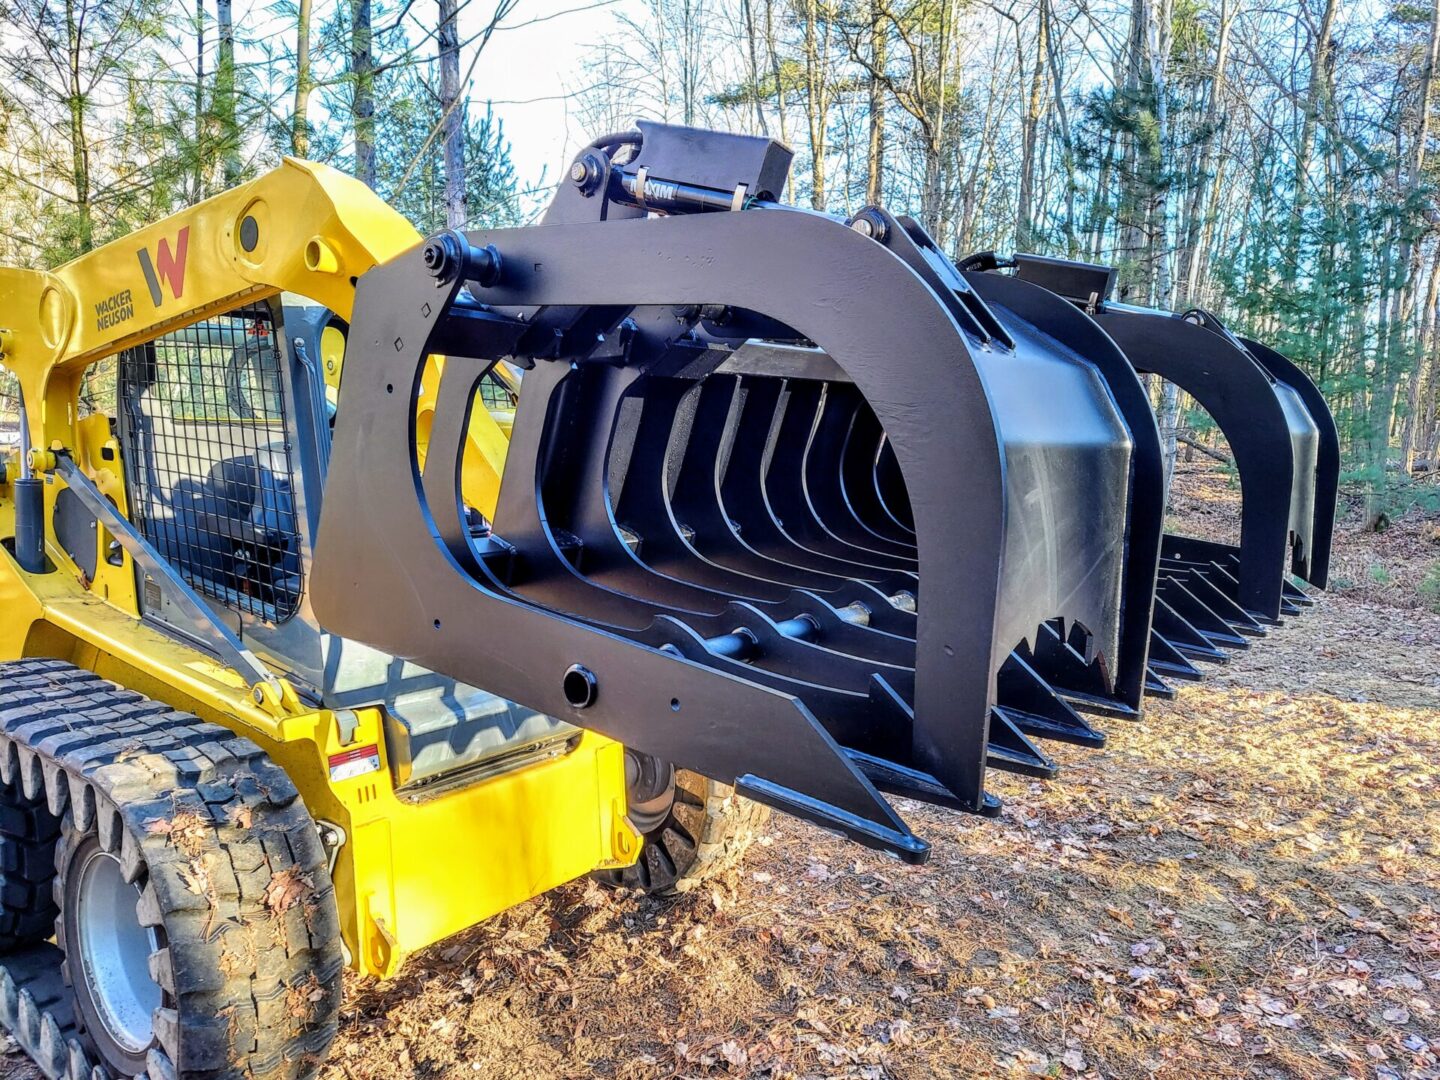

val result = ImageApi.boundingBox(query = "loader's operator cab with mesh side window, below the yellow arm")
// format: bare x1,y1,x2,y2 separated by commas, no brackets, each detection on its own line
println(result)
112,294,567,789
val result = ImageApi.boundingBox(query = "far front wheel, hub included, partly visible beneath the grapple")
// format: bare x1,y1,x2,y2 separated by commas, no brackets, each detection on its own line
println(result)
595,749,770,896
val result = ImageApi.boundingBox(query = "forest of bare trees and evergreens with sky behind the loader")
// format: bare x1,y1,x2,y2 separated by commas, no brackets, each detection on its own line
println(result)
0,0,1440,541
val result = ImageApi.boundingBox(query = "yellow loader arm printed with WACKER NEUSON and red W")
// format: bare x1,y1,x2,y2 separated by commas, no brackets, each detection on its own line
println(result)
0,158,504,578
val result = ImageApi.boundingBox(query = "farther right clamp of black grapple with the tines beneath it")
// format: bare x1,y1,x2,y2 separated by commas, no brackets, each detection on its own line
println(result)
1015,255,1339,678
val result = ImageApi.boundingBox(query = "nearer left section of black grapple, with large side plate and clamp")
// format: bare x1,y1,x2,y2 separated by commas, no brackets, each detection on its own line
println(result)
312,124,1163,861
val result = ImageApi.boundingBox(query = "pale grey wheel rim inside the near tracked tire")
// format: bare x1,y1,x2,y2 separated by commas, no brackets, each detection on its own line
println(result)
72,850,161,1054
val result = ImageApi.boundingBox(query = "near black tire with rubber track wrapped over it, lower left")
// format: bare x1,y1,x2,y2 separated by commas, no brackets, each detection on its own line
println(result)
0,660,343,1080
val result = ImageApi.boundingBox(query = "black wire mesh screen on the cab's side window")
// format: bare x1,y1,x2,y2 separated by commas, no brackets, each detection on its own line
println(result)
120,305,304,622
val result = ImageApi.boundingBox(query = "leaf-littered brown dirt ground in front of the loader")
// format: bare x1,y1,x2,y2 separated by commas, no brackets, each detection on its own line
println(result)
0,467,1440,1080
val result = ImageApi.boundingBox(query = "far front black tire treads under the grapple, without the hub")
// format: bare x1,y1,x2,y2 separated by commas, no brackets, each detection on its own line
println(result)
595,769,770,896
